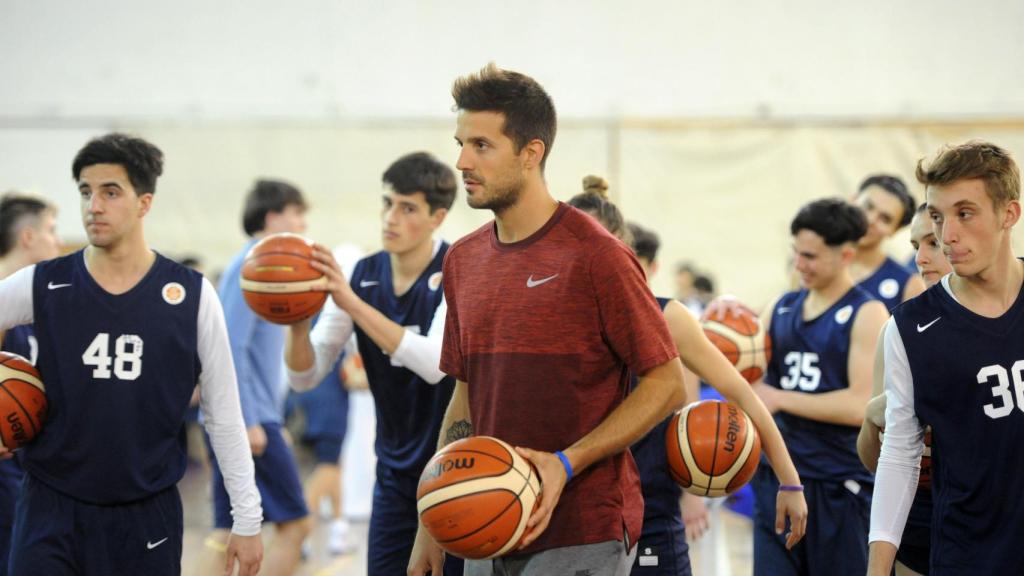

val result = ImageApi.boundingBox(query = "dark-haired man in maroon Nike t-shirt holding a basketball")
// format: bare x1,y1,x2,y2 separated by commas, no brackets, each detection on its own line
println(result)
409,65,685,576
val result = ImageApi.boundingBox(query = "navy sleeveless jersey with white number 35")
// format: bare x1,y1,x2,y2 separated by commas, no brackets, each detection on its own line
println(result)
765,286,873,483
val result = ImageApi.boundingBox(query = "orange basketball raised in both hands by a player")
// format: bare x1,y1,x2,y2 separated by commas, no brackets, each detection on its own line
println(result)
241,234,327,324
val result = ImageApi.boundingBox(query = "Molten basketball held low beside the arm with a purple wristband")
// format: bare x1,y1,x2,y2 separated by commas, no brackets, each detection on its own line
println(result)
665,400,761,497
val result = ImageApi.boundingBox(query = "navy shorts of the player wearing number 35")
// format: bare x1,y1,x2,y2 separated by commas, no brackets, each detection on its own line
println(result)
751,463,872,576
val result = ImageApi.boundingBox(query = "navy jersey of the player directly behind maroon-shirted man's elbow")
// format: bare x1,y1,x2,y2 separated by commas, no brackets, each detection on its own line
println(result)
630,298,683,522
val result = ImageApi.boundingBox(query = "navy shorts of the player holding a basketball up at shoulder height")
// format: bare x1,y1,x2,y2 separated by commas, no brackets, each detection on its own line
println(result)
367,461,463,576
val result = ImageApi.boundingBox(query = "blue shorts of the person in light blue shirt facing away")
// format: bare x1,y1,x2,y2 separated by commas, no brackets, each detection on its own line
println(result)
206,424,309,529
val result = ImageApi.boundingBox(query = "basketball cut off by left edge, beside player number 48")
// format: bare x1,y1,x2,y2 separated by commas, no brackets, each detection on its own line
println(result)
0,352,47,450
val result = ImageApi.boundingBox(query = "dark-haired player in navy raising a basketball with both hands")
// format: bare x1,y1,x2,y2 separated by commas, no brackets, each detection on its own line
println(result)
286,153,462,576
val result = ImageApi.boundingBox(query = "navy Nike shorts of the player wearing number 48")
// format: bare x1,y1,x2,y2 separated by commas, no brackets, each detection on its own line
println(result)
9,475,183,576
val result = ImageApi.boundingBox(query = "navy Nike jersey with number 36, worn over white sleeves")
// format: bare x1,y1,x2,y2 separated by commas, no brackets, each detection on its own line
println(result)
893,283,1024,574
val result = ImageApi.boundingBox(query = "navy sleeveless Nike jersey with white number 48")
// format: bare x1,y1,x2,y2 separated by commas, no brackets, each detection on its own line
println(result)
22,251,203,504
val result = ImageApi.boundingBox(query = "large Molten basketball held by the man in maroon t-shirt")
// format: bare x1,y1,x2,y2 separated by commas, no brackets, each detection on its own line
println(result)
416,436,541,559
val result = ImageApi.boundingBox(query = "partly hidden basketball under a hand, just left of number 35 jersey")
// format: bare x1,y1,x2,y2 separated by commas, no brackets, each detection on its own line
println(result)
700,306,771,382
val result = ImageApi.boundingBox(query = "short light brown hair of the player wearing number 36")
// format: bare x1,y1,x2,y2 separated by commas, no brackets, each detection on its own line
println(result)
916,140,1021,208
